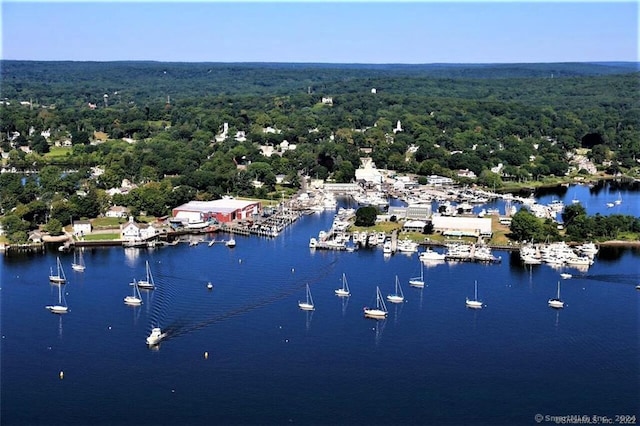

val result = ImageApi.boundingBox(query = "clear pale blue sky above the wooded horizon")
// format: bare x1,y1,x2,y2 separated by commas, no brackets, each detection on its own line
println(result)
0,0,639,64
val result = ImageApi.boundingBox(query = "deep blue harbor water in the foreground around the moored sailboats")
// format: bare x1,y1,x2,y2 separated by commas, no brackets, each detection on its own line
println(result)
0,188,640,425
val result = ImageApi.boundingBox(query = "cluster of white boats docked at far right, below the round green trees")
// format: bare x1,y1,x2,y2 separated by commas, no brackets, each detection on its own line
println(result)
520,241,599,268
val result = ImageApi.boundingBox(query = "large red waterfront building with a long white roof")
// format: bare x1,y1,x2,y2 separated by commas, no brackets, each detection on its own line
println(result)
171,198,262,223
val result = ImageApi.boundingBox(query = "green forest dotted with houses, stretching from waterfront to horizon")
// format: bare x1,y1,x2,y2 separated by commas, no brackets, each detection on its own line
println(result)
0,61,640,245
